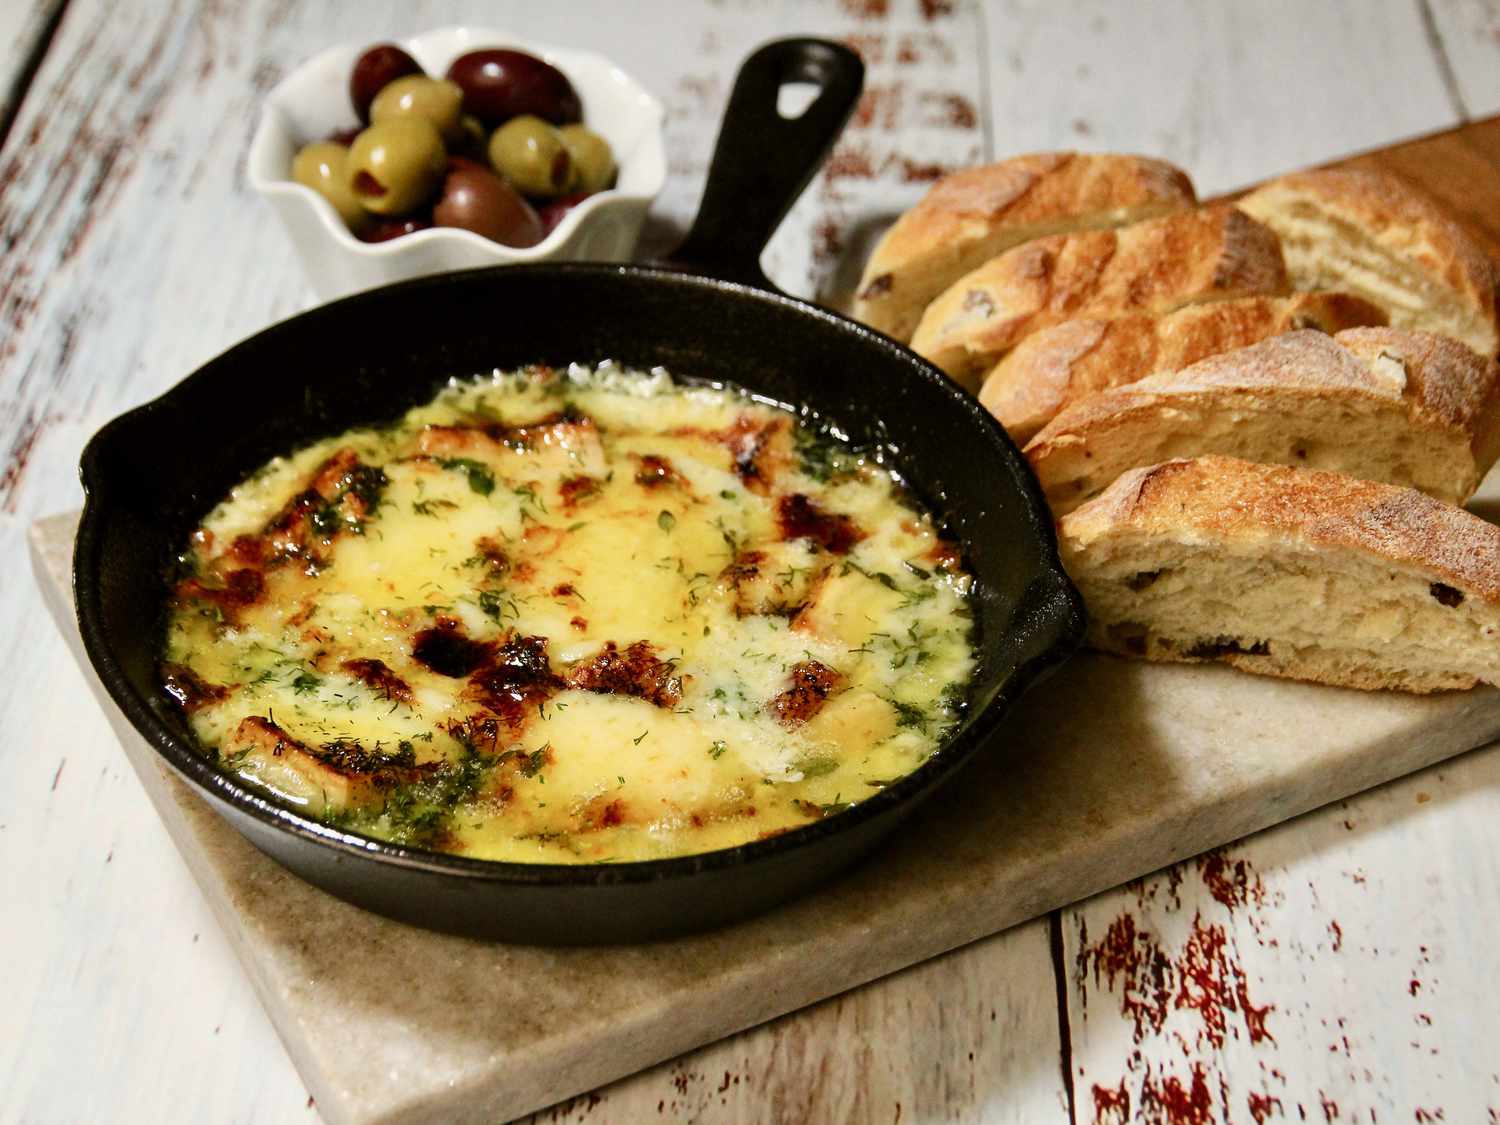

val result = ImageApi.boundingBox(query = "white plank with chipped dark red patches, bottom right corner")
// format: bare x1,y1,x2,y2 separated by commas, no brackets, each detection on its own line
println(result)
1064,749,1500,1125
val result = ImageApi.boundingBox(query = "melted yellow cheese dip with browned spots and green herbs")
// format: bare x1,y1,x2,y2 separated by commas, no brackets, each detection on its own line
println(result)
162,365,975,863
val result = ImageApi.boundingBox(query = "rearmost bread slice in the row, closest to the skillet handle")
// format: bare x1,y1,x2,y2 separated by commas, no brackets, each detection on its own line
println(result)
854,153,1197,344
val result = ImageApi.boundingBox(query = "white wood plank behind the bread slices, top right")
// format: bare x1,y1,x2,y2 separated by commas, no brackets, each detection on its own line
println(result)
984,0,1457,195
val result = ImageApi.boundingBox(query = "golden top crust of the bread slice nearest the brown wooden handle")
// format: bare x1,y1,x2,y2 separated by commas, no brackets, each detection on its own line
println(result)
1239,168,1500,357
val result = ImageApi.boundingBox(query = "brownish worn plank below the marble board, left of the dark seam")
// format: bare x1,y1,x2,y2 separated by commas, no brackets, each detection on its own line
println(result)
528,920,1068,1125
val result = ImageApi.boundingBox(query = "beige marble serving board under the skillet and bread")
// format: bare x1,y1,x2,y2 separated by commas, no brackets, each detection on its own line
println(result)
32,515,1500,1122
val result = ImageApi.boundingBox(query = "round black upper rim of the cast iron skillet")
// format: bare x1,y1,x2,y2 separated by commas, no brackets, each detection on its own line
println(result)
72,263,1085,888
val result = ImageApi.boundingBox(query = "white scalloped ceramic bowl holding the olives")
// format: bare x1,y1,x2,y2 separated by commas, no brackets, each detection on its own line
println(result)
248,27,666,300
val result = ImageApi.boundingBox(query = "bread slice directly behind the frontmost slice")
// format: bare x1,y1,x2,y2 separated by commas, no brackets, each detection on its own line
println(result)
1026,329,1500,516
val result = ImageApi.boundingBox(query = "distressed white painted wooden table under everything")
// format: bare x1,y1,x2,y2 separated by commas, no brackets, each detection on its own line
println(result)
0,0,1500,1122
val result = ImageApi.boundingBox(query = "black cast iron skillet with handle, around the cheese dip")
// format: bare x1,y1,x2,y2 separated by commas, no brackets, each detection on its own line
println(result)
74,39,1083,942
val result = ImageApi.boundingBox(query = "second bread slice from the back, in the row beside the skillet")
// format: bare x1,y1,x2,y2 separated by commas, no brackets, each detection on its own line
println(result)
912,204,1290,392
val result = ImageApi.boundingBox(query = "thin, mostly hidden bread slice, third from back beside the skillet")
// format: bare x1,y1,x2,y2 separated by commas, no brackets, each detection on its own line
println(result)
980,293,1386,443
